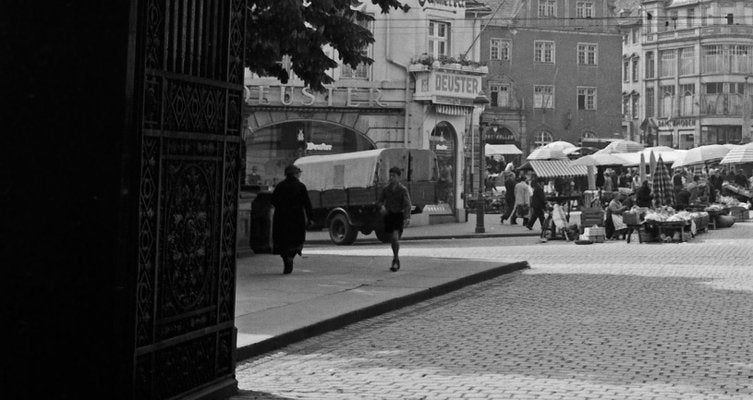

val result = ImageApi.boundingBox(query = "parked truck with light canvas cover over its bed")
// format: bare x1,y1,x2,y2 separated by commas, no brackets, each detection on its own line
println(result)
295,148,439,245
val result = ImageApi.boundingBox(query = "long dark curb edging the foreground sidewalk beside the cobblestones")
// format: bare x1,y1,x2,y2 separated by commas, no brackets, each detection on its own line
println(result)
235,261,531,362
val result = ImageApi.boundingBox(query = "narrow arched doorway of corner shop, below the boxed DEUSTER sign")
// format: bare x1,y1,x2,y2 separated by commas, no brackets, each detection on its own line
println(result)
429,121,457,212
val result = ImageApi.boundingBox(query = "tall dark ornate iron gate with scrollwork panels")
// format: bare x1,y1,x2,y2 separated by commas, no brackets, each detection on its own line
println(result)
133,0,246,399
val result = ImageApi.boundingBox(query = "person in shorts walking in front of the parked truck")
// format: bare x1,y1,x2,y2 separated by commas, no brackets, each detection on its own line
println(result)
377,167,411,272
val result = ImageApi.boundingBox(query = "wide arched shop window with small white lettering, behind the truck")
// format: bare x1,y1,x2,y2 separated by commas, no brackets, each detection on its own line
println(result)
245,120,376,188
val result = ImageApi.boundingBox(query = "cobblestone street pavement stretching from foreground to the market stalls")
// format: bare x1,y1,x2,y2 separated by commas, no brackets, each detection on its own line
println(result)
236,223,753,400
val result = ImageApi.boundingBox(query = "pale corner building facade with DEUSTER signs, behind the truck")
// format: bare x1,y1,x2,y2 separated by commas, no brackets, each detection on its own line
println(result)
244,0,487,223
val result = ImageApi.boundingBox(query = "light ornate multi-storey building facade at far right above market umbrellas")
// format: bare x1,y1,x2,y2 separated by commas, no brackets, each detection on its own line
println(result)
623,0,753,149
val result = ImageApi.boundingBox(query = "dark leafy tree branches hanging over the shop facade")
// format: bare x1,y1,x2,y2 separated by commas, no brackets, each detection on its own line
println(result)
246,0,408,91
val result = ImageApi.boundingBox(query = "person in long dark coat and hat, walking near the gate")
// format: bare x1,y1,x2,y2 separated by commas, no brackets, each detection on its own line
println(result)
272,165,311,274
